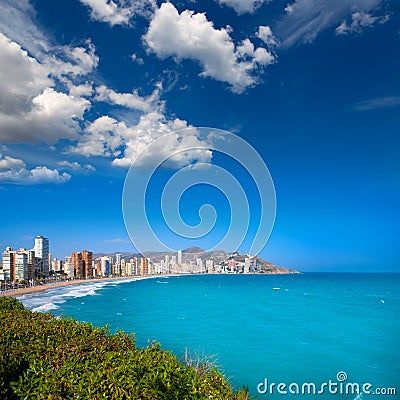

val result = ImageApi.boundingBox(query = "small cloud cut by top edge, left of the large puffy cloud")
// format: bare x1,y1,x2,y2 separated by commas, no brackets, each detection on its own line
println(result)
80,0,155,26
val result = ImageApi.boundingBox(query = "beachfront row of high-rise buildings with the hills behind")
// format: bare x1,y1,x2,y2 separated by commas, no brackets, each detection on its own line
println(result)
0,235,299,284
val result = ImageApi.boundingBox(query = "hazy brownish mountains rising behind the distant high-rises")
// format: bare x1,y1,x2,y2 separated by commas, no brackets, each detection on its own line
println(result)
93,247,299,274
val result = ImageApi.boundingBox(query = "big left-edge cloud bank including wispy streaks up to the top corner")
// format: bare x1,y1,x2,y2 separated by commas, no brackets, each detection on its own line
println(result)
0,0,99,144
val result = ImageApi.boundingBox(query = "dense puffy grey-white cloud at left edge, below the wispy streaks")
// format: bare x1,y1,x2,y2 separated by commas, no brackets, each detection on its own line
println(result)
0,34,90,144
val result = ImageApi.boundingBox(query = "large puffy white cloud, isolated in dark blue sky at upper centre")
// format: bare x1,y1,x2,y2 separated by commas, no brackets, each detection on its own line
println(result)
143,3,273,93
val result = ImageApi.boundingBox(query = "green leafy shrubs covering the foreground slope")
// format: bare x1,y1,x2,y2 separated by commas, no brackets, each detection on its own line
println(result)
0,298,252,400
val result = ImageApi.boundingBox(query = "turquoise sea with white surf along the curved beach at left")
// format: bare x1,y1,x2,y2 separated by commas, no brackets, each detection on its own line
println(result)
19,273,400,399
